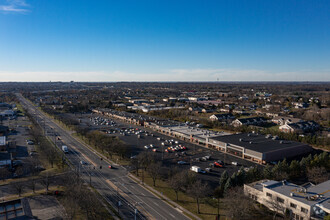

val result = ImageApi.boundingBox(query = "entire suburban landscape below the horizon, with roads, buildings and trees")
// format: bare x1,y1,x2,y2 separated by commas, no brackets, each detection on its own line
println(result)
0,82,330,219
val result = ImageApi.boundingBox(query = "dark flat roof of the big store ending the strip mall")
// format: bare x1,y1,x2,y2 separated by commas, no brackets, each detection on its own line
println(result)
211,133,308,153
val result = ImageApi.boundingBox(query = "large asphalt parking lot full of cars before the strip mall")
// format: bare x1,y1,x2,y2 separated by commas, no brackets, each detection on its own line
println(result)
77,114,257,185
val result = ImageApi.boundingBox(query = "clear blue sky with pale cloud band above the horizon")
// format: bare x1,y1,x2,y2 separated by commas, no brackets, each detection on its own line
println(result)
0,0,330,81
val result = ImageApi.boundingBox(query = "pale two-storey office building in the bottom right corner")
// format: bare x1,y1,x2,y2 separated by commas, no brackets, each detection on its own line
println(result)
244,180,330,220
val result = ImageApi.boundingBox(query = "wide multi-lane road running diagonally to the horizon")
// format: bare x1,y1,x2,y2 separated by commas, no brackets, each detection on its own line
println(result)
16,94,189,219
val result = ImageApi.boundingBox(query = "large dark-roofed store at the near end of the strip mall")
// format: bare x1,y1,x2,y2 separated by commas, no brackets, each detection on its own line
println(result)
207,133,312,164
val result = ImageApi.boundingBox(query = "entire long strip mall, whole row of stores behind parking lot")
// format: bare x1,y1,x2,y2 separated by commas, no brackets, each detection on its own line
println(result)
93,109,312,164
